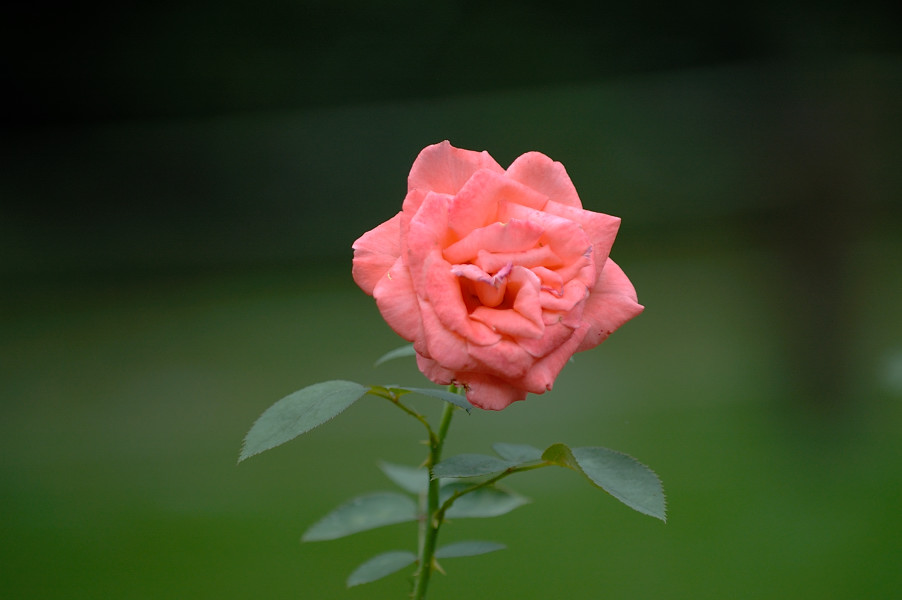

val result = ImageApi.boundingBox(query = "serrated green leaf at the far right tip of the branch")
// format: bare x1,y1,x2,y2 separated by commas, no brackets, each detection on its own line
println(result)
542,444,667,521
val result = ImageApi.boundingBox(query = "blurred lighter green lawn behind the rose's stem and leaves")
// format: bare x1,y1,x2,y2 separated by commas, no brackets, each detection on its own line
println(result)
0,226,902,598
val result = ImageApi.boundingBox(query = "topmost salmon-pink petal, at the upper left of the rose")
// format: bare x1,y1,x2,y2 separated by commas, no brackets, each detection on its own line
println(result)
407,140,504,195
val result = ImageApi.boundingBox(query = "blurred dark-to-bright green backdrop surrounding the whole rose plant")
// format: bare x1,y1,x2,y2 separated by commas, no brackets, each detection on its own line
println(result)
0,0,902,600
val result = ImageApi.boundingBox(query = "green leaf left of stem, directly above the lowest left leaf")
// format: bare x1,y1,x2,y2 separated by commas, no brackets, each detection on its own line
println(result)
301,492,417,542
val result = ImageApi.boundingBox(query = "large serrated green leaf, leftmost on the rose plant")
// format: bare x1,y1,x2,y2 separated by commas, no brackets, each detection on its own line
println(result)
238,380,367,462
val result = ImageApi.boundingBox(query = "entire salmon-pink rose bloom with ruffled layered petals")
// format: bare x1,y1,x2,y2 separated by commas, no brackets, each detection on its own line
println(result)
353,141,643,410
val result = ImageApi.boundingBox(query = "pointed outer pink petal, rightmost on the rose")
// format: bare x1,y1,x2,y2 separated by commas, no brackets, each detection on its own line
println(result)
577,259,645,352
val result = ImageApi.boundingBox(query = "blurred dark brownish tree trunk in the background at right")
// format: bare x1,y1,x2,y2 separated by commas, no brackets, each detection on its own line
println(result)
763,70,870,417
